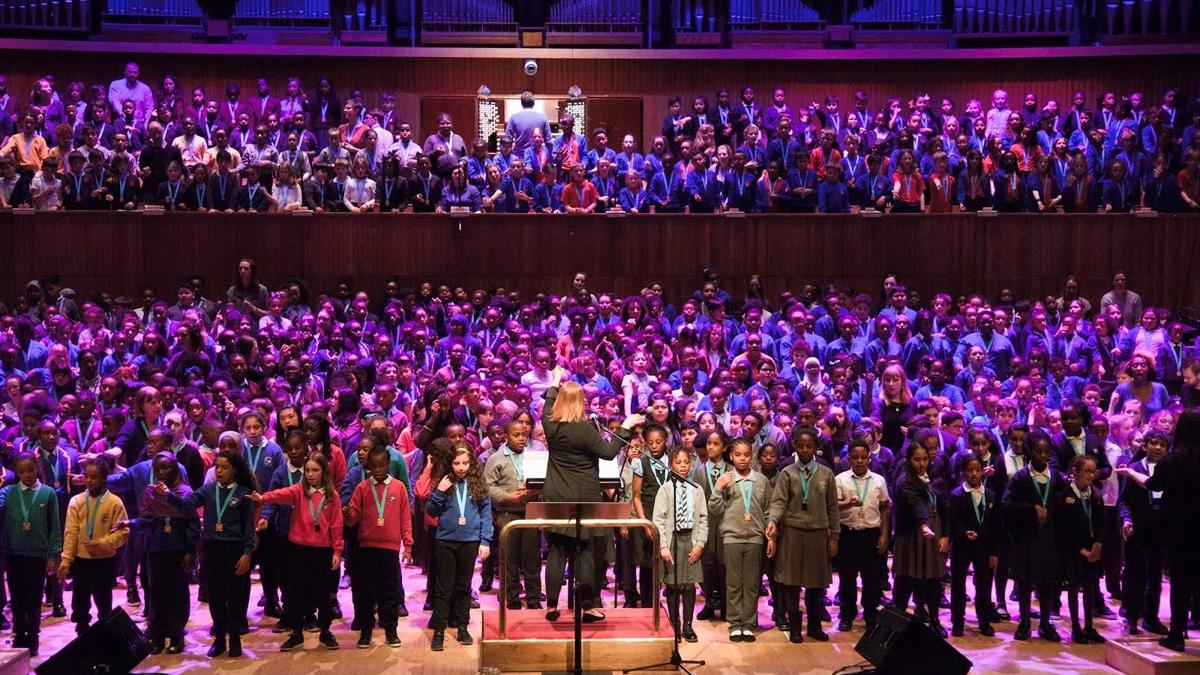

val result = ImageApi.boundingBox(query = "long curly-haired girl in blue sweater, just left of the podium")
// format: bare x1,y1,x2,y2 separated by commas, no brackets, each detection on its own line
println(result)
425,446,492,651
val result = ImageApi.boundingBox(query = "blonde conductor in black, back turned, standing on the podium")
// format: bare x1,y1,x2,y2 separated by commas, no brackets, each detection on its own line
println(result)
541,381,646,623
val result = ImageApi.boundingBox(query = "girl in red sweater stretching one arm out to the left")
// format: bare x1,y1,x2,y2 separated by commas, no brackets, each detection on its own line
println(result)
250,454,343,651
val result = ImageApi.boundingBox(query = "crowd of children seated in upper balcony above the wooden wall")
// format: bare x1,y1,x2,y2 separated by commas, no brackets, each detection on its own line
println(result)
0,69,1200,214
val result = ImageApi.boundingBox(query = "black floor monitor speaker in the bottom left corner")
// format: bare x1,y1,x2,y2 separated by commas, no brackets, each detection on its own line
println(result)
34,608,150,675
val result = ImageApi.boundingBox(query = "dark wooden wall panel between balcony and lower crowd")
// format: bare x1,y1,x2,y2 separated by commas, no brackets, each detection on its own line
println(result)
0,213,1200,307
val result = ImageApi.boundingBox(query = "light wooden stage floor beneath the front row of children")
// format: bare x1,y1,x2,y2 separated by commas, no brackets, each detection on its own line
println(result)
11,568,1200,675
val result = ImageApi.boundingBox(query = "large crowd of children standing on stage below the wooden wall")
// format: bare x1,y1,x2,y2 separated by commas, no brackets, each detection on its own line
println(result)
0,261,1200,657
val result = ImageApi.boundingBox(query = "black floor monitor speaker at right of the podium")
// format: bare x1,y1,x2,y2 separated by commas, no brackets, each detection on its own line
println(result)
854,607,971,675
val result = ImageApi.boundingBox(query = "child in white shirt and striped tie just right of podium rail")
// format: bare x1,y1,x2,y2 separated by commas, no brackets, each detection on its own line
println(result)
654,448,708,643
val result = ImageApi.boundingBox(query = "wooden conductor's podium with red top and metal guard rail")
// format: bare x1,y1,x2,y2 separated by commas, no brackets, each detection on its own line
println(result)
480,502,673,673
